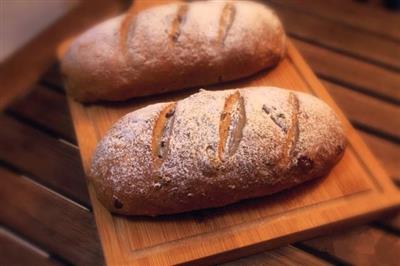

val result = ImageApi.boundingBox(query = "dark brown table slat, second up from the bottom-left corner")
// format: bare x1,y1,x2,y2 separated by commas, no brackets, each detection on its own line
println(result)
0,168,103,265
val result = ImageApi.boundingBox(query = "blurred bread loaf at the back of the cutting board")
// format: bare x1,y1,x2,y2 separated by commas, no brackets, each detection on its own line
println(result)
62,1,286,102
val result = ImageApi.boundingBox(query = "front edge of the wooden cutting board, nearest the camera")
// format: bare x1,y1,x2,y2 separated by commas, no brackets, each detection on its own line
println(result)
99,190,400,265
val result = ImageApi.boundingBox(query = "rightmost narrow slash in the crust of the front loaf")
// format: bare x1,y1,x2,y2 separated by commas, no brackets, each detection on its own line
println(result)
278,92,299,169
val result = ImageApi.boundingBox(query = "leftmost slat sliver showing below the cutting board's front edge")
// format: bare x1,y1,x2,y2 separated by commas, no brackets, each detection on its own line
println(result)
221,246,330,266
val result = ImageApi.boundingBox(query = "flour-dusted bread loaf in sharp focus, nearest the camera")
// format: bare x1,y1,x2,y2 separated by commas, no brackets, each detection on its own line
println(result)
90,87,345,216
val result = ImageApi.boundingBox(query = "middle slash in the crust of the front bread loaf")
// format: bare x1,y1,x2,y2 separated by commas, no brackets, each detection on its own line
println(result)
218,91,246,161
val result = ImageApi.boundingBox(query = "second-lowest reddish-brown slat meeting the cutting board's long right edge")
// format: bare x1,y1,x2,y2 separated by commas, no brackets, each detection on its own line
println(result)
323,81,400,140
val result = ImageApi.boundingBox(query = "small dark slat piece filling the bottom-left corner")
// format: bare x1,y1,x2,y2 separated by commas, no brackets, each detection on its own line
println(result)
0,227,59,266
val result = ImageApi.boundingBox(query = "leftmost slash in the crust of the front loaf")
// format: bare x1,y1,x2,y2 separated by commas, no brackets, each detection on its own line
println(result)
151,102,176,170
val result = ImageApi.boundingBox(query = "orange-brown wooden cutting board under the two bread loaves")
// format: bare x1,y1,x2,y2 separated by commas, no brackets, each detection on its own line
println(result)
64,1,400,265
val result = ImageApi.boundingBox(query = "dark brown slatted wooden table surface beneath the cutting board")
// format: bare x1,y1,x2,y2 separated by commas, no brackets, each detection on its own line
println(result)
0,0,400,265
